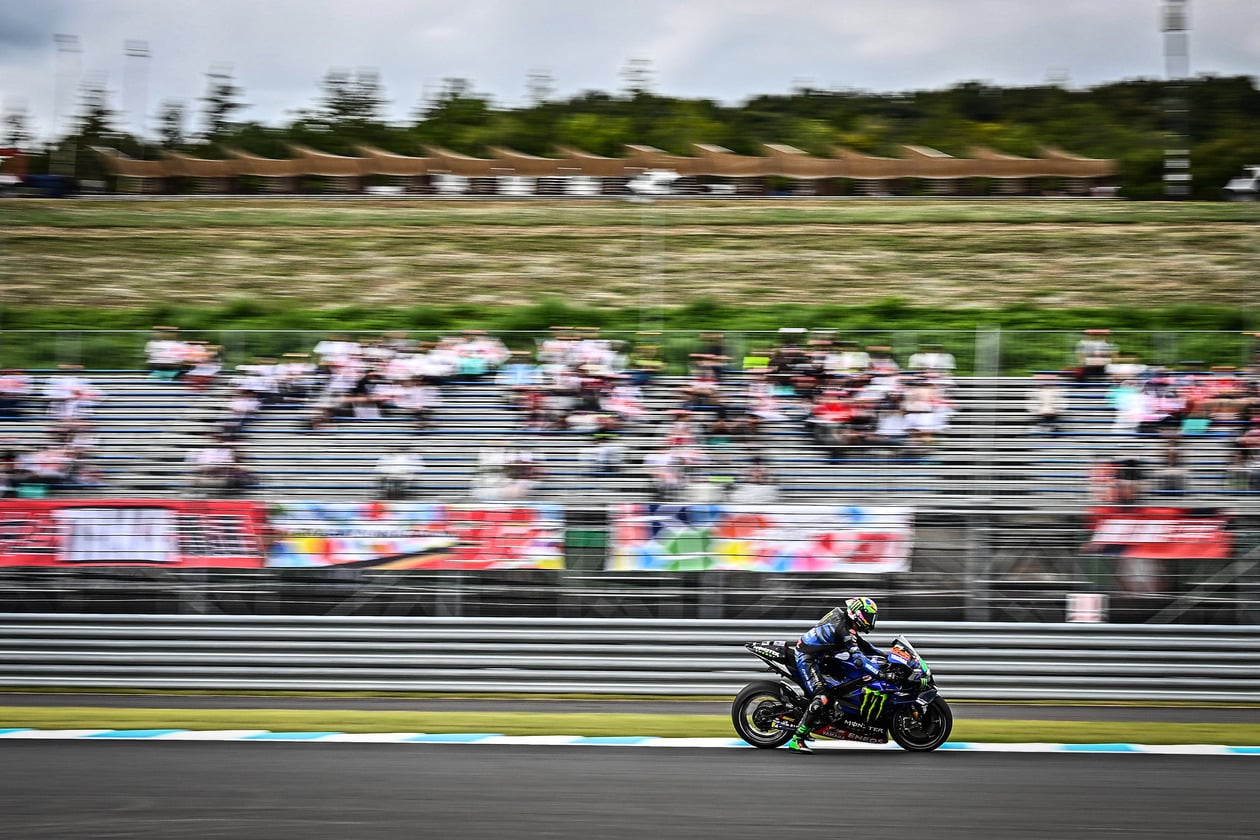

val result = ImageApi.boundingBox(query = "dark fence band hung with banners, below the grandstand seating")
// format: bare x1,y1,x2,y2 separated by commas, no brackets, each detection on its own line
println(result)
0,499,1260,626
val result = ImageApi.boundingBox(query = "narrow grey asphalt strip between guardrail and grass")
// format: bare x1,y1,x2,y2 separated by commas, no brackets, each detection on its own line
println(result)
0,693,1260,723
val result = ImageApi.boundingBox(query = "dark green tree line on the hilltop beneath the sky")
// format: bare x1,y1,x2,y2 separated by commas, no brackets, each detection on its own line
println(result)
4,69,1260,199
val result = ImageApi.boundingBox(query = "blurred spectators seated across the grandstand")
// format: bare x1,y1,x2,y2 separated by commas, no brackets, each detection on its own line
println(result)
7,327,1260,504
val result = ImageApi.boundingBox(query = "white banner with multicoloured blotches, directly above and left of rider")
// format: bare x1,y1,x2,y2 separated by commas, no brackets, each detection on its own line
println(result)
607,504,914,573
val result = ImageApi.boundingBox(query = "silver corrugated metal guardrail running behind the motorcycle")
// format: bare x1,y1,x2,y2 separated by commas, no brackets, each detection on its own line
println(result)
0,613,1260,703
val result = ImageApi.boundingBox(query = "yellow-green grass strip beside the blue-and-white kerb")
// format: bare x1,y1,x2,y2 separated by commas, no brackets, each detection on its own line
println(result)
0,707,1260,747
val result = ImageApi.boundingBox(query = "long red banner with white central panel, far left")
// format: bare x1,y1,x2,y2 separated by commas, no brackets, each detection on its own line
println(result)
0,499,267,569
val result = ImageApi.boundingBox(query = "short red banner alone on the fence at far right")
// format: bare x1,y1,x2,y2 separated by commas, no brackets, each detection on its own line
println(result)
1081,508,1234,560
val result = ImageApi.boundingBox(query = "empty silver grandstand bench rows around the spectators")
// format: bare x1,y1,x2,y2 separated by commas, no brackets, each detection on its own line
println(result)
9,372,1260,513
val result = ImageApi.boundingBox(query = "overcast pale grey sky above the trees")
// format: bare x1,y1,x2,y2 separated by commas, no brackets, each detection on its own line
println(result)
0,0,1260,136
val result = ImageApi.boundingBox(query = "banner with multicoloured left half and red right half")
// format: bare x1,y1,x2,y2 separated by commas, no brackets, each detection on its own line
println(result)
267,501,564,569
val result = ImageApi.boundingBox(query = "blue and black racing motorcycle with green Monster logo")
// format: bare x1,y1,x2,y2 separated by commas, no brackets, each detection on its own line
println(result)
731,636,954,752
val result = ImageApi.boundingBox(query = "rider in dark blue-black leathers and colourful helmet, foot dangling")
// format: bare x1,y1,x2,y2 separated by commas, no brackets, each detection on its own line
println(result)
788,598,879,754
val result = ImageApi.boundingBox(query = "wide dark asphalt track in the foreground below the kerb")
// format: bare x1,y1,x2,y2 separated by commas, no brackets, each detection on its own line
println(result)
0,742,1260,840
